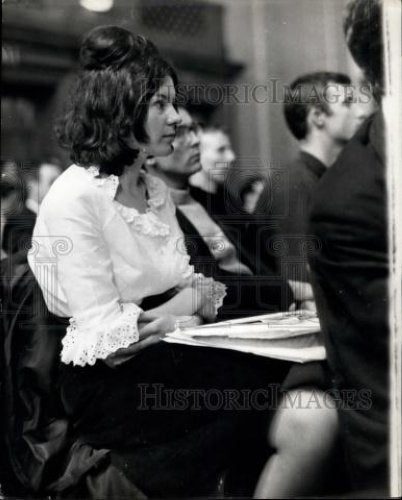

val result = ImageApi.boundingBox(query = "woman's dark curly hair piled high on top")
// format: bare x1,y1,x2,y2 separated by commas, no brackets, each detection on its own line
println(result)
56,26,178,175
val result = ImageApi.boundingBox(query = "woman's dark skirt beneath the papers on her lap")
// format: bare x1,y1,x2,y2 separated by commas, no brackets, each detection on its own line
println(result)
61,342,289,496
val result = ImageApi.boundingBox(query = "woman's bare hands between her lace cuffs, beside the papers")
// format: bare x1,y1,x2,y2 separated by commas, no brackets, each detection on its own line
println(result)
104,312,177,368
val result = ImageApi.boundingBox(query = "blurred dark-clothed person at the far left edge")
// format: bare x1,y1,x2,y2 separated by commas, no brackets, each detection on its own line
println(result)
1,161,36,259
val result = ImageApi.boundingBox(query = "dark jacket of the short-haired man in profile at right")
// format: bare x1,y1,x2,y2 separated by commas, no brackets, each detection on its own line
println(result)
251,152,327,281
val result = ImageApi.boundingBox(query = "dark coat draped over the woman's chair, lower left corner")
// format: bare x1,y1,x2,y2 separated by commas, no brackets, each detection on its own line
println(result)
0,251,145,498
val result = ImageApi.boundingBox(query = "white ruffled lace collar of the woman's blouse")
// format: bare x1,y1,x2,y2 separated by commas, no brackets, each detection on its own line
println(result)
87,166,170,236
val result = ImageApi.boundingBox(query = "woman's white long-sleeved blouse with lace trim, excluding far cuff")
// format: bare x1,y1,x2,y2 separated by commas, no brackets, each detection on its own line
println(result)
28,165,193,366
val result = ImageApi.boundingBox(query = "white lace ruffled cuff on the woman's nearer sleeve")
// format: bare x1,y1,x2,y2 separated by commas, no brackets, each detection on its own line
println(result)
61,304,142,366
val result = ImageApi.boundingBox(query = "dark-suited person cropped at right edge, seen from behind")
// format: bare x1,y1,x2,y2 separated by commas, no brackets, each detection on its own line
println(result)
309,0,390,498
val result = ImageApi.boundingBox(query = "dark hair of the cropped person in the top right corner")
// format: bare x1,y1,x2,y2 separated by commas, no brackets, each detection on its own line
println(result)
343,0,384,99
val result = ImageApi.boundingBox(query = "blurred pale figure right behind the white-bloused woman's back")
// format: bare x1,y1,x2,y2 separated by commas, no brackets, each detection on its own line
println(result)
24,160,63,214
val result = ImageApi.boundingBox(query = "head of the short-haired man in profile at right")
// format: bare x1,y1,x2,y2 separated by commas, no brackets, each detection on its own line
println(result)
284,71,356,140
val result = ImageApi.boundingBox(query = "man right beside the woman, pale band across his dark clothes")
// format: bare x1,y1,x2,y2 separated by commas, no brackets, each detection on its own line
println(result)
147,107,302,319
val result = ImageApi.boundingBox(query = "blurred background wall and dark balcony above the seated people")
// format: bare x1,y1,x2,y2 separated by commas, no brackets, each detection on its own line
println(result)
2,0,361,186
